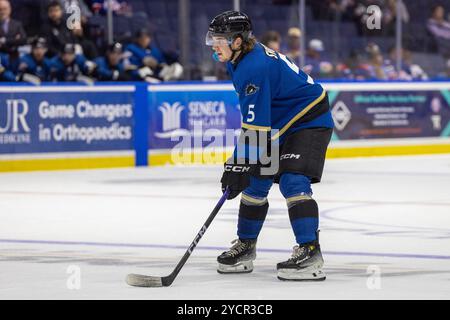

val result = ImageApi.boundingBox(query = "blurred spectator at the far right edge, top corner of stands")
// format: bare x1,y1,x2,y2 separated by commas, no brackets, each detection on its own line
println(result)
427,5,450,57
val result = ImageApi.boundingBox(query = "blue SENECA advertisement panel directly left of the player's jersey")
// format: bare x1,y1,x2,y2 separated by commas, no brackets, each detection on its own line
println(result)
148,84,241,149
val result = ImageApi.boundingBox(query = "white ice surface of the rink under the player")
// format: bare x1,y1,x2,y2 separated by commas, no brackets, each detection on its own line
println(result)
0,155,450,299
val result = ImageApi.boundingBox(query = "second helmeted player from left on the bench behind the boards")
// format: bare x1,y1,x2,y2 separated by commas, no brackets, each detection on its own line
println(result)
51,43,96,83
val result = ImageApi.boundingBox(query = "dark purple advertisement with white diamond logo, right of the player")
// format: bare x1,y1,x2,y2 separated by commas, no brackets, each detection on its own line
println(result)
325,83,450,140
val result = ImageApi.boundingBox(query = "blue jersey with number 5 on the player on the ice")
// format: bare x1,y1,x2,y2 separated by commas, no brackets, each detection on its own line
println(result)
227,43,333,140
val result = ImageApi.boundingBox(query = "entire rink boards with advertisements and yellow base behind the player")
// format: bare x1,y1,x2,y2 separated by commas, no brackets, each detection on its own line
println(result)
0,82,450,171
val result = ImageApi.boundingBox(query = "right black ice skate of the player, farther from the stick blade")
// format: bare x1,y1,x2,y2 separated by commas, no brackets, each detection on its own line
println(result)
277,241,326,281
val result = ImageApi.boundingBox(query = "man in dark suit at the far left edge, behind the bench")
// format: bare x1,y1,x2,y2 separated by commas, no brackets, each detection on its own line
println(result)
0,0,27,67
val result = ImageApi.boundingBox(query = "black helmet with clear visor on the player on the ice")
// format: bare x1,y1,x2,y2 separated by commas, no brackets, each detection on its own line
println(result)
205,11,252,46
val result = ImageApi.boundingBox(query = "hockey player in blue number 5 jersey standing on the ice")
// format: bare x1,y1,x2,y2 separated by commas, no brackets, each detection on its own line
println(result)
206,11,333,280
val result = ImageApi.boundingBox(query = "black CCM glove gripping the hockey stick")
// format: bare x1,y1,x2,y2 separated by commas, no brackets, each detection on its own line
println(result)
220,161,256,199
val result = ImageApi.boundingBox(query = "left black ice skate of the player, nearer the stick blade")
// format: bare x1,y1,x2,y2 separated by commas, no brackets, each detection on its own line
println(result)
217,239,256,273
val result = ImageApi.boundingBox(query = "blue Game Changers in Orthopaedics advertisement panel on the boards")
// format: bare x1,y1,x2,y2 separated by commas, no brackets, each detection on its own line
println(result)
0,86,134,154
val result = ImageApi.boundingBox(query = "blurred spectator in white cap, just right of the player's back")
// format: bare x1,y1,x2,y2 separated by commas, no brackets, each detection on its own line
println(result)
303,39,334,79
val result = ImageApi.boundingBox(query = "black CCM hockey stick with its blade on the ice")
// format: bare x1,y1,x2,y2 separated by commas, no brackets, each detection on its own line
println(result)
126,189,230,287
